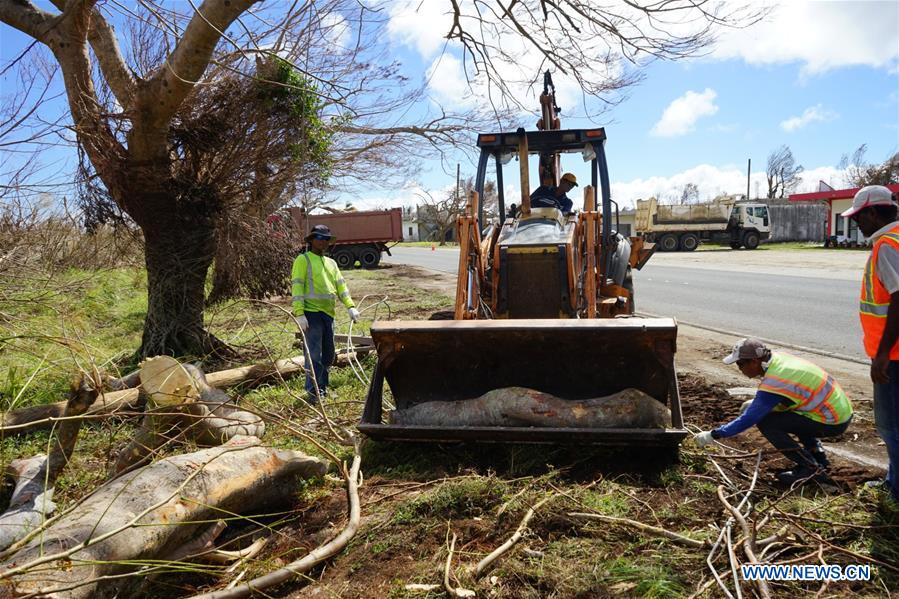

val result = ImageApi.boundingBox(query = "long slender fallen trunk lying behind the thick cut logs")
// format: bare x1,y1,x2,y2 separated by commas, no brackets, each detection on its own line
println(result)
0,346,372,437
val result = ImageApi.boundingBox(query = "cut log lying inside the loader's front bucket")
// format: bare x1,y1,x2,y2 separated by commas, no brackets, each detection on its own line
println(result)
390,387,671,428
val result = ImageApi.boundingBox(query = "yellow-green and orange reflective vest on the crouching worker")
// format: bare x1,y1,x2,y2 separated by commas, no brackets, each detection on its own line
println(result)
759,353,852,424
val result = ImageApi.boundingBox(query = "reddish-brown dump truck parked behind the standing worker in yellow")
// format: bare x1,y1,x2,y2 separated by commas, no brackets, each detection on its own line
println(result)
269,207,403,269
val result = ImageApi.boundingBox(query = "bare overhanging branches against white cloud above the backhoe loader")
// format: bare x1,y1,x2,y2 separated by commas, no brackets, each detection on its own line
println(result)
446,0,768,109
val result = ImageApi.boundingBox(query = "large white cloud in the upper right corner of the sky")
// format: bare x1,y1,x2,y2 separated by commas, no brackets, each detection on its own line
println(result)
713,0,899,74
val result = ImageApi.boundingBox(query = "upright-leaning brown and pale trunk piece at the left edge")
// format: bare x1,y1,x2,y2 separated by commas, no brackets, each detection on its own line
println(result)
0,375,97,550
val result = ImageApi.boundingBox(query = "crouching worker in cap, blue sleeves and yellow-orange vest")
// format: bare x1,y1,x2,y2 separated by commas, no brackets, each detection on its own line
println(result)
695,339,852,484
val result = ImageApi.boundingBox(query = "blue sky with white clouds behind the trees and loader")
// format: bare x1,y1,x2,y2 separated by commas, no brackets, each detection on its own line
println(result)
0,0,899,207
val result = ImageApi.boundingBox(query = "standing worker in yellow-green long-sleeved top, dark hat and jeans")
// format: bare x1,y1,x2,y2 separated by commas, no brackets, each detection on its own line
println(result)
290,225,359,405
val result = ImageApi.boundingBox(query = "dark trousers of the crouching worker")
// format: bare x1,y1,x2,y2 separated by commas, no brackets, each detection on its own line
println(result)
757,412,852,470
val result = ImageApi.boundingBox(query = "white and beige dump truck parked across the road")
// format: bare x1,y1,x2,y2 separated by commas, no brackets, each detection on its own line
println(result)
635,196,771,252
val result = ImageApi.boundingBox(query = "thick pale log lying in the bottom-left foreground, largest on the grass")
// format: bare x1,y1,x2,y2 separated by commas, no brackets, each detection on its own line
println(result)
0,437,328,599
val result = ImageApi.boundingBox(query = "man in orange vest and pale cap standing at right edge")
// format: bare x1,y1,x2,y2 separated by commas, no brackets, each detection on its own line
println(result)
842,185,899,512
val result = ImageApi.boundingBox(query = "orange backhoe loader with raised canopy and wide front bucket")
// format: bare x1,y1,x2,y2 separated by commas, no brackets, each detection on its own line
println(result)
357,74,688,451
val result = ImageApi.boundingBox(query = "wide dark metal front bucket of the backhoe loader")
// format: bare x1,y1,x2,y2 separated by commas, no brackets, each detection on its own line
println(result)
358,318,688,446
